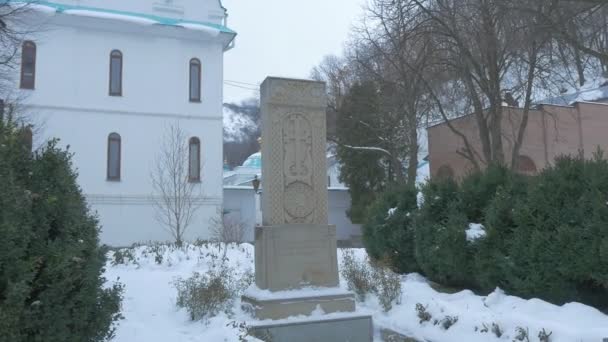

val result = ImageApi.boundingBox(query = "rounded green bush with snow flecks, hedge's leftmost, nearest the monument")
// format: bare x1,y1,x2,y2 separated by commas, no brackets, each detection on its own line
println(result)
363,187,419,273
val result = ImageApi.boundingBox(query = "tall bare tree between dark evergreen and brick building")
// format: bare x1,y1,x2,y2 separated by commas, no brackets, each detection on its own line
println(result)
353,0,432,184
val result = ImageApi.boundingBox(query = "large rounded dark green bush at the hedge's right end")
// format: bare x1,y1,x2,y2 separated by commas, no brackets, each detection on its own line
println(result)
507,154,608,307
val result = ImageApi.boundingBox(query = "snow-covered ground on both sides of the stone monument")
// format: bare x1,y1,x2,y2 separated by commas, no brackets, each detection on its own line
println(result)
105,244,608,342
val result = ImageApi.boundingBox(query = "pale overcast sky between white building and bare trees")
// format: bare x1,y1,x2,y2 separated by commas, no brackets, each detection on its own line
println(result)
222,0,364,102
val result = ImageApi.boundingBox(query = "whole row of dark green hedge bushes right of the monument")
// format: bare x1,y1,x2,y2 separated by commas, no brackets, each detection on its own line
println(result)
363,154,608,308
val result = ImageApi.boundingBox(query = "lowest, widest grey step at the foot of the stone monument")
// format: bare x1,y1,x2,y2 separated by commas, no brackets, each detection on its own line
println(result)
249,315,373,342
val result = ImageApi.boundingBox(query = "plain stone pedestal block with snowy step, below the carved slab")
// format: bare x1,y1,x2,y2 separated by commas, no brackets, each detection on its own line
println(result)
243,224,355,319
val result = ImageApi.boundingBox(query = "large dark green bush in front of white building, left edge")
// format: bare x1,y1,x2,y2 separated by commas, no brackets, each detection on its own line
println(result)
0,122,122,342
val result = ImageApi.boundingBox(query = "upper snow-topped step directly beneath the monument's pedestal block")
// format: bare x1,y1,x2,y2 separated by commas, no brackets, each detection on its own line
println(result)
241,290,355,319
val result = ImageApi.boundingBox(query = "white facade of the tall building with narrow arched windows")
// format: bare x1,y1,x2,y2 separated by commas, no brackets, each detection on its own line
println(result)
17,0,235,246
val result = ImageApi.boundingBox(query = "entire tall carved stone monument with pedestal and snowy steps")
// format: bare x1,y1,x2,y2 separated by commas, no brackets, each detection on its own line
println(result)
243,77,372,342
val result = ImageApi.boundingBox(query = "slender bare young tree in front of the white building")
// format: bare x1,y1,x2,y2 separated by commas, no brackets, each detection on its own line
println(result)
150,124,203,246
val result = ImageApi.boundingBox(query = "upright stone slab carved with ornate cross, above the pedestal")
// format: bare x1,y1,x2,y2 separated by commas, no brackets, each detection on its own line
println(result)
262,78,327,225
